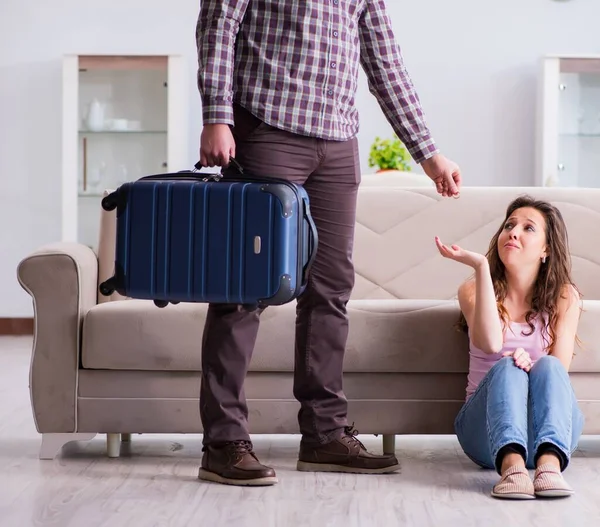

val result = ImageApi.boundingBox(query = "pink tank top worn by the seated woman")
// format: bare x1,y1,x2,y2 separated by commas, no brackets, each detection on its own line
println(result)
467,317,548,399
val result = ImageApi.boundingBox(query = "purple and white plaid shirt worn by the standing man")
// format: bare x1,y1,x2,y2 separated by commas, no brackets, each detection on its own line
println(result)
196,0,437,163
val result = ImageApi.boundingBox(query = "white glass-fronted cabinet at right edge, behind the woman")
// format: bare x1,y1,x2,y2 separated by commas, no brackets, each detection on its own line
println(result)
536,56,600,188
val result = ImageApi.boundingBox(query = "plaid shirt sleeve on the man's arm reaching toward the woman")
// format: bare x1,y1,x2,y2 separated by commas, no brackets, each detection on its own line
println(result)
359,0,438,163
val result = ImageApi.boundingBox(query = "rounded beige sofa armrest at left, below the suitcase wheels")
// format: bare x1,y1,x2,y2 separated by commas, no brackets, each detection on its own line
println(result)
17,243,98,433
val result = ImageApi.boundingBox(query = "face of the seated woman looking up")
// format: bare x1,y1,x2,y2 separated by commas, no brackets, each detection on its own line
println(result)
498,207,547,268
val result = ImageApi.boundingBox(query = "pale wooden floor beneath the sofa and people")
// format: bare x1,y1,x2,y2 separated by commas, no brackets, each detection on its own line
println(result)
0,337,600,527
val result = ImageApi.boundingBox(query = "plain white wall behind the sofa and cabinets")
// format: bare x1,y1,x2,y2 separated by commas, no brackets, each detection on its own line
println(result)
0,0,600,317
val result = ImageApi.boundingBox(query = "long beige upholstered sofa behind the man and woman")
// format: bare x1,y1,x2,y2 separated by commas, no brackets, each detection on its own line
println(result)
18,174,600,459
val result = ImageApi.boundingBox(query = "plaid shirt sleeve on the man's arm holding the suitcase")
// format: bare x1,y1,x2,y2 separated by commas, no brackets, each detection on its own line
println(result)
196,0,249,125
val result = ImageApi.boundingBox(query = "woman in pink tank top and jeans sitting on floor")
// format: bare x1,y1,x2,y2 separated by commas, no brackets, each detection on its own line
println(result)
435,196,584,499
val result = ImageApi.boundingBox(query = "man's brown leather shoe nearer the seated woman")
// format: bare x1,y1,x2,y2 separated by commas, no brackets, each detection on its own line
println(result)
296,426,400,474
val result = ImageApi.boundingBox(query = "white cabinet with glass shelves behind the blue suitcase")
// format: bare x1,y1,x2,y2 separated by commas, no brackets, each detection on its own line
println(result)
62,55,191,249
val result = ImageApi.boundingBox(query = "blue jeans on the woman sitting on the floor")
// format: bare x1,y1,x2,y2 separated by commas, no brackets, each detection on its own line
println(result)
454,356,584,470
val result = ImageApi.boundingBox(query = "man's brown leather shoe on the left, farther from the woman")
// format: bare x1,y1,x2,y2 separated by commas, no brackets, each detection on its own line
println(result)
198,441,277,487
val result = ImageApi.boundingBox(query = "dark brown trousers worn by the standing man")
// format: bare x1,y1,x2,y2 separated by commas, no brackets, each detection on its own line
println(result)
200,107,360,445
